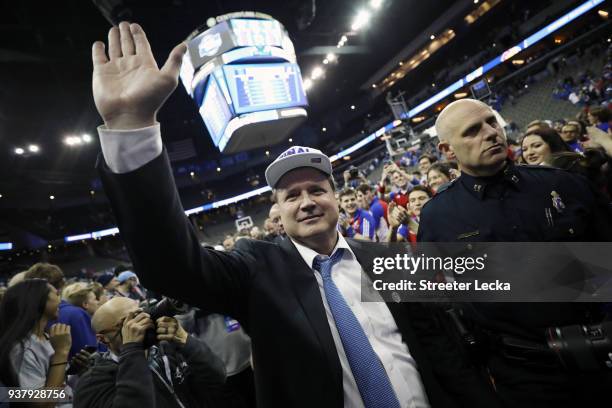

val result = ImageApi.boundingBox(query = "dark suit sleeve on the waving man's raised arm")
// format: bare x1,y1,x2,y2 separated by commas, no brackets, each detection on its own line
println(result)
98,150,255,319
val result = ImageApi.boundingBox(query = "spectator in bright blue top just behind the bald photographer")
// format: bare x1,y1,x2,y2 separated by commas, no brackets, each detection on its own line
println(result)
58,282,98,359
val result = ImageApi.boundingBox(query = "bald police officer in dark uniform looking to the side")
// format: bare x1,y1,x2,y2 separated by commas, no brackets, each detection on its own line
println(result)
418,99,612,407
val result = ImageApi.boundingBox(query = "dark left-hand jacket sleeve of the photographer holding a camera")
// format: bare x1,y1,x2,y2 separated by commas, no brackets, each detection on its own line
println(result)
74,343,155,408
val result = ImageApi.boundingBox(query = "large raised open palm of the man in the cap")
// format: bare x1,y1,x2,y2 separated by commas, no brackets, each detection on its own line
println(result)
92,22,187,129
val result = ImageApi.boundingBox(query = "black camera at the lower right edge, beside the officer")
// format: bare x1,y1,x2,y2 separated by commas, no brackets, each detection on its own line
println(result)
546,321,612,371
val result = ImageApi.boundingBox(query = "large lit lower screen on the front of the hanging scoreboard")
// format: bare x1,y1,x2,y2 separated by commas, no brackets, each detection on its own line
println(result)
223,63,308,114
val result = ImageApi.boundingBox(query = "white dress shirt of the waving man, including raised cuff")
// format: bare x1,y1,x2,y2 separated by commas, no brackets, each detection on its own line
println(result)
98,124,429,408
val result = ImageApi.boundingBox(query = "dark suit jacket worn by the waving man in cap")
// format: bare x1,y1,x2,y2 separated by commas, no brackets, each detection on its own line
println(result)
99,152,497,408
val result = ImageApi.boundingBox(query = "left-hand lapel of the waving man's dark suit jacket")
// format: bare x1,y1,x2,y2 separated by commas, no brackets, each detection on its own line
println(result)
280,239,342,398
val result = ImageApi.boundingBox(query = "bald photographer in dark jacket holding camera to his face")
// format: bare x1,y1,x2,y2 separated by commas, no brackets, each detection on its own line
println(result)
74,297,225,408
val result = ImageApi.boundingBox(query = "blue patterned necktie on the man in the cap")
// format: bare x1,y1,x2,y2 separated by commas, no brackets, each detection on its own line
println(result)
313,248,400,408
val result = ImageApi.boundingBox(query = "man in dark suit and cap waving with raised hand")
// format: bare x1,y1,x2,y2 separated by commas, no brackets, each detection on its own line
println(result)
93,23,497,408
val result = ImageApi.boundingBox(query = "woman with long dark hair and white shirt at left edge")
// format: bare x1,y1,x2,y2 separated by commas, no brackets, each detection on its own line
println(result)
0,279,72,407
